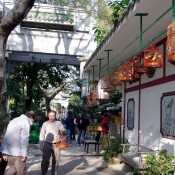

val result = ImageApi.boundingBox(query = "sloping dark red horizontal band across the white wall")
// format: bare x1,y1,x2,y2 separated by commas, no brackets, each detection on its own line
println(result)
125,74,175,93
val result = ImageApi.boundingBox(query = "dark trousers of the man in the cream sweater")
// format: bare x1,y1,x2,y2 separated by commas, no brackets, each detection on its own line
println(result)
41,142,61,175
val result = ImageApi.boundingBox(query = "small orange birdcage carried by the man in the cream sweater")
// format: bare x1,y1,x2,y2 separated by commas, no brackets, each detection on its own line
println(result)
55,131,69,148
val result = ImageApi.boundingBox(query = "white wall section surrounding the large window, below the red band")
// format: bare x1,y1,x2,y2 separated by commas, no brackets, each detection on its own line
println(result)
140,81,175,153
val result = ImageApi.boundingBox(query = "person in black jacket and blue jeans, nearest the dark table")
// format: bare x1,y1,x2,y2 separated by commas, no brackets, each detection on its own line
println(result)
77,114,89,145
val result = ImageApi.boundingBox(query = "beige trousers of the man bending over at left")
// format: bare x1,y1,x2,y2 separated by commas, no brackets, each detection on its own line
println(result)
6,156,26,175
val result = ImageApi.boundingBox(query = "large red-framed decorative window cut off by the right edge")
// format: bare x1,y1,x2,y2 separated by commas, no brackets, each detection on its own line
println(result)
160,91,175,139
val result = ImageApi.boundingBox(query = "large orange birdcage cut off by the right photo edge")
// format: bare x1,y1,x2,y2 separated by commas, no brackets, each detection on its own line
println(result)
167,22,175,65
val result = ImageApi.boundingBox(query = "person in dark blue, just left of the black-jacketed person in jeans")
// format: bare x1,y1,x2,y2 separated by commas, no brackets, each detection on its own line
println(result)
65,111,75,146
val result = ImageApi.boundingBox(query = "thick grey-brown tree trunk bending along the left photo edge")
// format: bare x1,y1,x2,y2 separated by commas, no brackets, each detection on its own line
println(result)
0,0,35,108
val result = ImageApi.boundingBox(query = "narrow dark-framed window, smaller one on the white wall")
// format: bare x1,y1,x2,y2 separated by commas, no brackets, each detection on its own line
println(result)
127,98,135,131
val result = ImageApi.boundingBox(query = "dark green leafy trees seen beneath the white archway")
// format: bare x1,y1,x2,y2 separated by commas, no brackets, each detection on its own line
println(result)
7,63,79,116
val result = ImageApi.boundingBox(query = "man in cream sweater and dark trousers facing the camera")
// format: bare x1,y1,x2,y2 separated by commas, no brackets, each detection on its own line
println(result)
40,111,65,175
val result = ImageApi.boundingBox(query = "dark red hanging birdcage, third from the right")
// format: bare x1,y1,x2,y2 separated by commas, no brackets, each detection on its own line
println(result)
133,53,148,74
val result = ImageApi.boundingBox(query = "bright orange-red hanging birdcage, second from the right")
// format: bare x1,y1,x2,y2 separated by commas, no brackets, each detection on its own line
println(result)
144,45,163,68
